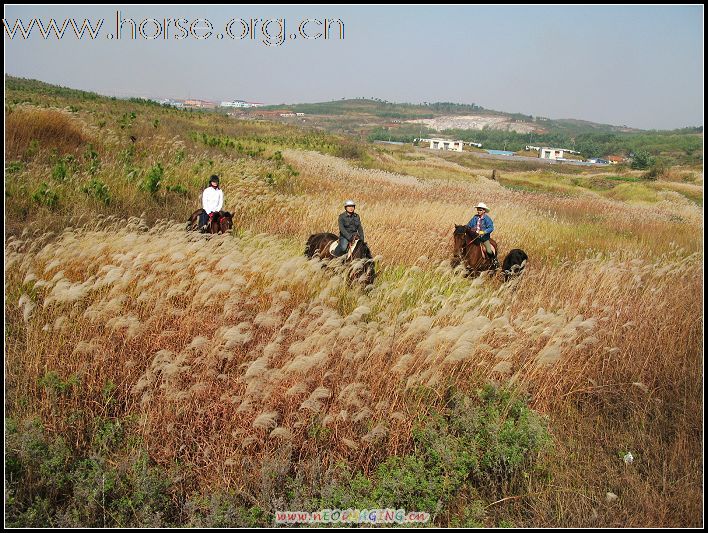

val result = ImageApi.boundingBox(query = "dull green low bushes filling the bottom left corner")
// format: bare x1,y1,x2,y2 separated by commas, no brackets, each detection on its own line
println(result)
5,414,177,527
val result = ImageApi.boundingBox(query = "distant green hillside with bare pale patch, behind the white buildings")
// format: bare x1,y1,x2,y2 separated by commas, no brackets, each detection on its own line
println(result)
253,99,703,162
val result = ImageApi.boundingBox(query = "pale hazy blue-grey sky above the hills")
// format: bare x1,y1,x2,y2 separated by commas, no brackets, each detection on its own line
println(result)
4,5,703,129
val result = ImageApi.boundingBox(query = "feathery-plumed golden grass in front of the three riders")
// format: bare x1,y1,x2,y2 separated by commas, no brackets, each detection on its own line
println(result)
6,202,702,520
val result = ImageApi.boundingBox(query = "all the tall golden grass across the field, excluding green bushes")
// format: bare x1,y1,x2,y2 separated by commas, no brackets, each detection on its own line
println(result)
5,94,703,526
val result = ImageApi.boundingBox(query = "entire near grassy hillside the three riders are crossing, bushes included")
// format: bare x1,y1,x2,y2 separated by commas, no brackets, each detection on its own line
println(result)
5,80,703,527
